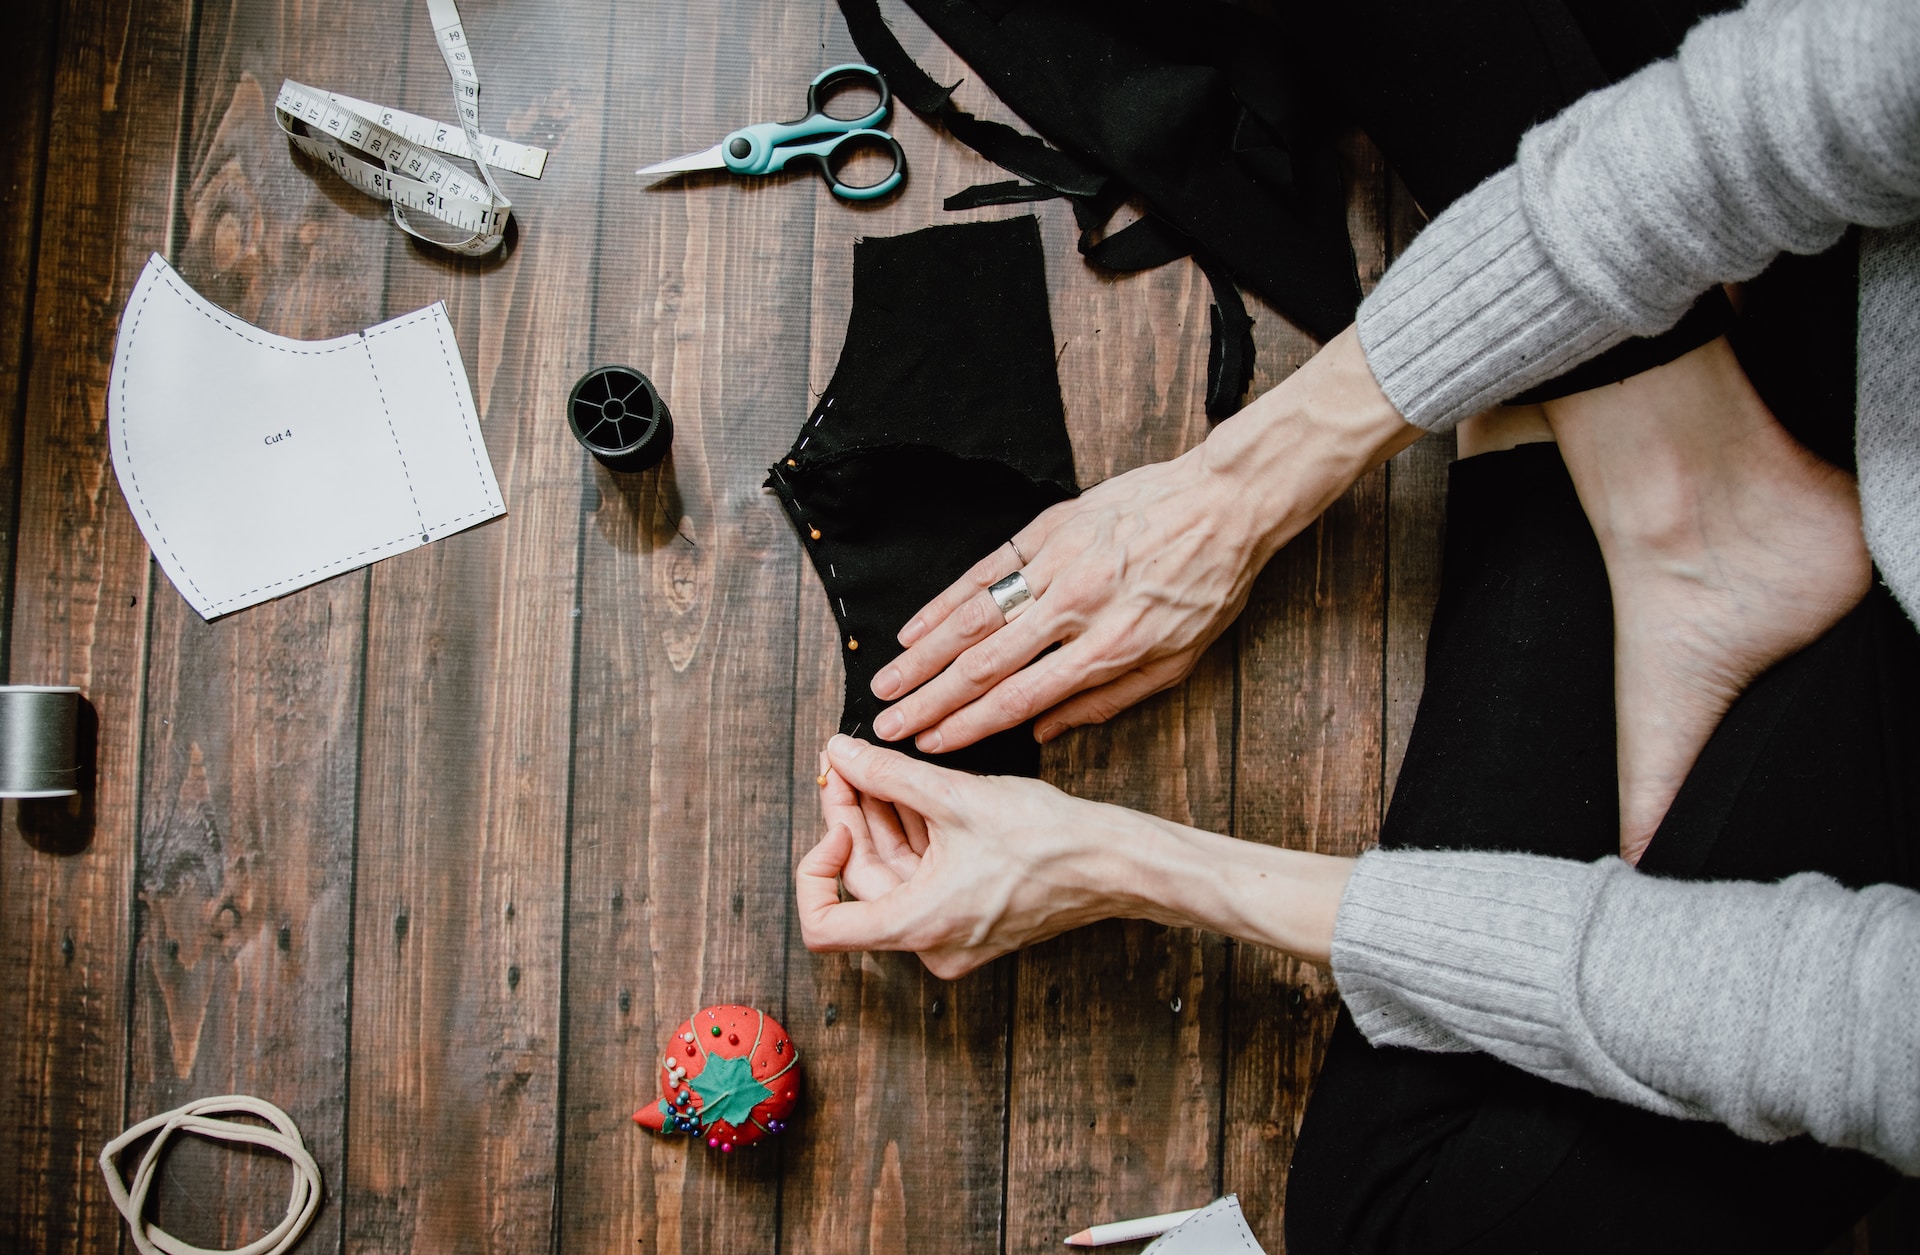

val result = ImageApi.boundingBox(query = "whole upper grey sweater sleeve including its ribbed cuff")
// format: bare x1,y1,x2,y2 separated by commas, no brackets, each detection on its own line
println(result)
1357,0,1920,430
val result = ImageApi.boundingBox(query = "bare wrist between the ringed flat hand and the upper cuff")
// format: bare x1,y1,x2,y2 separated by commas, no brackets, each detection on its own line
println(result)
1187,326,1425,570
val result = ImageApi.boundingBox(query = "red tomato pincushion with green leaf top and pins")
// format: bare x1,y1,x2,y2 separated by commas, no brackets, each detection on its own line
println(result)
634,1006,801,1151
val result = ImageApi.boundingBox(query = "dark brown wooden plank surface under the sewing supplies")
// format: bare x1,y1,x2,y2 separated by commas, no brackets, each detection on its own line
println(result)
0,0,1895,1255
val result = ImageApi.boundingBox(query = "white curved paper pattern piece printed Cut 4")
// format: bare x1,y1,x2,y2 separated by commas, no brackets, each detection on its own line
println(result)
108,253,507,620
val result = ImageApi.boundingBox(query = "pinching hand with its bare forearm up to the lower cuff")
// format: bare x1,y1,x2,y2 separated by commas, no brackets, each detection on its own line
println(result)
795,737,1352,981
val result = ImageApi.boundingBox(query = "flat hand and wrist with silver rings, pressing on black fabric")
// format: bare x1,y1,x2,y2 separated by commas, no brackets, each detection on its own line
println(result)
874,328,1421,752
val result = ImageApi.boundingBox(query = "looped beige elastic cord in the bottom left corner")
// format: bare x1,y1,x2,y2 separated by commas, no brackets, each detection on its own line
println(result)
100,1094,321,1255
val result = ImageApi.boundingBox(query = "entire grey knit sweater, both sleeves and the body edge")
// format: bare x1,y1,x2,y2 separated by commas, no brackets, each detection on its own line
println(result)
1332,0,1920,1174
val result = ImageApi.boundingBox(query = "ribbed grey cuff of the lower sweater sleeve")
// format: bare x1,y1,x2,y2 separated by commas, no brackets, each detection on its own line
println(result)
1332,850,1680,1115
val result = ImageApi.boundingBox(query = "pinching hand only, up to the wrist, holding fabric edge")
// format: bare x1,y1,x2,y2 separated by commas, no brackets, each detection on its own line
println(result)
795,737,1156,981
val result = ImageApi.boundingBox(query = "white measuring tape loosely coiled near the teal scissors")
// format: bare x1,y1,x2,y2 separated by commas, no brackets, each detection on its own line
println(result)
273,0,547,257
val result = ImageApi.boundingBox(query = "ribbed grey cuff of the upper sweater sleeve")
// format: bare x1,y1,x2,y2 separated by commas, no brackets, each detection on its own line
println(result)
1357,167,1628,432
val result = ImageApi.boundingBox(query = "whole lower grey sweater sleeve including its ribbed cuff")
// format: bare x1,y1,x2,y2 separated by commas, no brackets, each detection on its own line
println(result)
1332,850,1920,1174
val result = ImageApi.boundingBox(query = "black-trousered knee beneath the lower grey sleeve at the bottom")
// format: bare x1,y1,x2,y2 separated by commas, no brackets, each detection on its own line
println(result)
1286,1013,1895,1255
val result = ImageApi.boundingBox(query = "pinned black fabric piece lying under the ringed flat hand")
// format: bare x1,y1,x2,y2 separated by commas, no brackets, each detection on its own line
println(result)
766,217,1079,775
